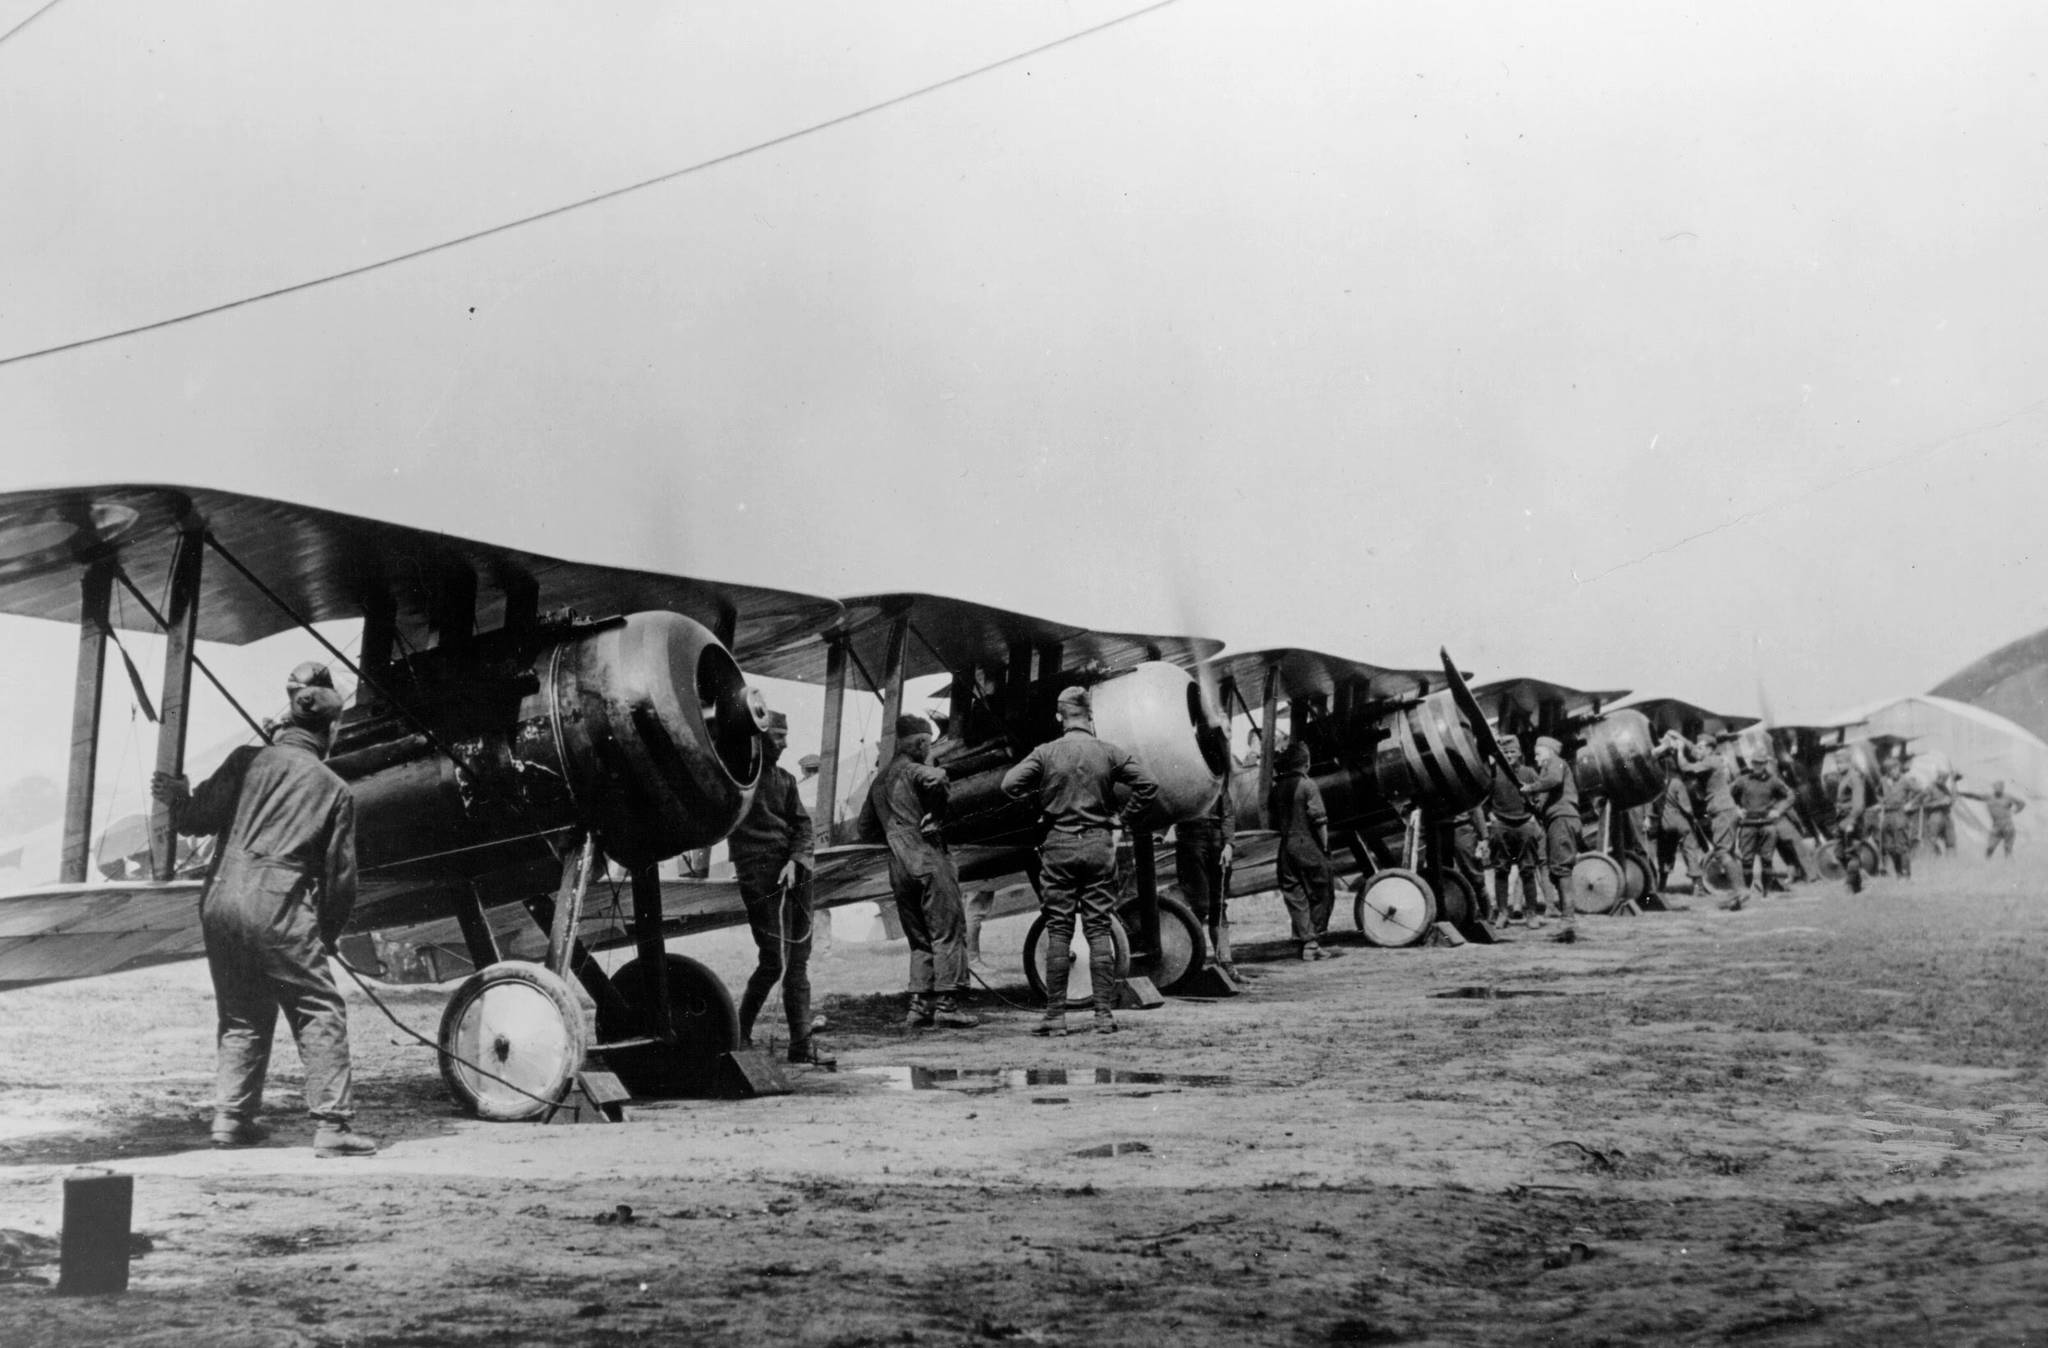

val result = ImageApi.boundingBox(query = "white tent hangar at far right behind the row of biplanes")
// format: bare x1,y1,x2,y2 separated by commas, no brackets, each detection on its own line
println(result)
1821,694,2048,846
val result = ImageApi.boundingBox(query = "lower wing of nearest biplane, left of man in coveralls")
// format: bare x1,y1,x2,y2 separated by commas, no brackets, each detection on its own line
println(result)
0,881,205,987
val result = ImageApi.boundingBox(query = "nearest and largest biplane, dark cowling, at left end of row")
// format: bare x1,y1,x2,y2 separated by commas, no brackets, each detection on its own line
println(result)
0,486,842,1117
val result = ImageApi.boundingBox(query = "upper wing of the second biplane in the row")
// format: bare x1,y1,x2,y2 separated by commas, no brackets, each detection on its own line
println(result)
748,594,1223,690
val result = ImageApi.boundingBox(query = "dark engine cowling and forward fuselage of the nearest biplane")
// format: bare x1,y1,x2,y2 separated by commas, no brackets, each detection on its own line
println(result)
330,613,762,867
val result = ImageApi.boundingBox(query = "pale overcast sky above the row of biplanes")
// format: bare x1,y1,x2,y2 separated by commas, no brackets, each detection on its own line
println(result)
0,0,2048,807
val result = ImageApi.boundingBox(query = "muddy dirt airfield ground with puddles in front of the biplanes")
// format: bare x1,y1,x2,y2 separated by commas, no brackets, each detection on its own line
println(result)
0,858,2048,1348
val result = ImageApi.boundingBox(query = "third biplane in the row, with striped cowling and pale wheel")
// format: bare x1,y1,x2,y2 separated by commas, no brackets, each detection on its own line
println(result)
1204,647,1501,946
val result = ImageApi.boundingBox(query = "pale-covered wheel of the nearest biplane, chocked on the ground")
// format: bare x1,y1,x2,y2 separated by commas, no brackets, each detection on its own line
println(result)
440,961,588,1123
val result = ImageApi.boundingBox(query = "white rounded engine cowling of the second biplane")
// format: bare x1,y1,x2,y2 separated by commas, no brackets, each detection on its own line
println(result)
1090,660,1229,828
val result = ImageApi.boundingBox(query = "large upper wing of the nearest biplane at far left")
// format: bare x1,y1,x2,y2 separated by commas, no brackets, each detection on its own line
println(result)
0,486,840,662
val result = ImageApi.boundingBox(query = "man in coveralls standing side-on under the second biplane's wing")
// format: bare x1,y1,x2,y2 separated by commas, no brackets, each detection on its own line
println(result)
868,713,981,1030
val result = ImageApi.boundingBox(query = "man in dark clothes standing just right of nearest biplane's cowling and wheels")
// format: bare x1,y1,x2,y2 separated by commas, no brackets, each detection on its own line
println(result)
725,711,831,1067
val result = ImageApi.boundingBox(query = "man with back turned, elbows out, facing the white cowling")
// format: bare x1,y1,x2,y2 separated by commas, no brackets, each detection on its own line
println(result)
1004,688,1159,1037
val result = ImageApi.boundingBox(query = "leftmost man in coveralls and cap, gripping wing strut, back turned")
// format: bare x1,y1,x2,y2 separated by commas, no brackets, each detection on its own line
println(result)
150,664,377,1155
